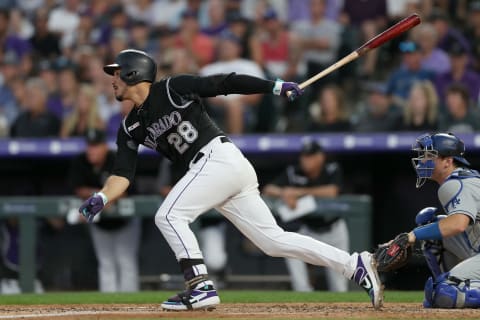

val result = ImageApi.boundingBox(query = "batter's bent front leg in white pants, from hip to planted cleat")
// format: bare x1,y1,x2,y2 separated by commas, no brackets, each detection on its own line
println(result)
155,139,248,310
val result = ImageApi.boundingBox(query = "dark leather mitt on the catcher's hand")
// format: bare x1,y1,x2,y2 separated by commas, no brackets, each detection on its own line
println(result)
373,232,412,272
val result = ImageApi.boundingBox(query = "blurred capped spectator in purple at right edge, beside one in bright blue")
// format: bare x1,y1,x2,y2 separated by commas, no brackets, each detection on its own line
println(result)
435,42,480,103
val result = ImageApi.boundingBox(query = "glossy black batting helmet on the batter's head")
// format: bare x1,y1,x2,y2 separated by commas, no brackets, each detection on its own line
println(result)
103,49,157,85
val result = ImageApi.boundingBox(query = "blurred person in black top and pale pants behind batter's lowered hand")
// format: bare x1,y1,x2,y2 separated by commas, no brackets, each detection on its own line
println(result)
69,129,141,292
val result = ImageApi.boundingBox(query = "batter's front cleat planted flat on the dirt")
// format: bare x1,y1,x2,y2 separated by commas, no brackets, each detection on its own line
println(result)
162,285,220,311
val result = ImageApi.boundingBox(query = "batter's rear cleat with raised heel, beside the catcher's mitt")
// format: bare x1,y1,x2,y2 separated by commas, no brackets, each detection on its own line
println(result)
352,251,383,309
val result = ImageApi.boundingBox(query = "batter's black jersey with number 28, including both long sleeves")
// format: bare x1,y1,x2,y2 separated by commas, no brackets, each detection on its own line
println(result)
113,73,274,181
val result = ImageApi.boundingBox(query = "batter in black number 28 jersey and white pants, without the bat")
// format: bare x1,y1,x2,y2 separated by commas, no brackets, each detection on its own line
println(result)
79,50,383,310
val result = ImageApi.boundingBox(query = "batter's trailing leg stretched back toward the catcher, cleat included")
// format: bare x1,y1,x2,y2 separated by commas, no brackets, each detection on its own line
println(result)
217,179,383,308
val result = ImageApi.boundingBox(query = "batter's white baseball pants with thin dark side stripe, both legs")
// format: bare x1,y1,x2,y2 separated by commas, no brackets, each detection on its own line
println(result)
155,137,358,278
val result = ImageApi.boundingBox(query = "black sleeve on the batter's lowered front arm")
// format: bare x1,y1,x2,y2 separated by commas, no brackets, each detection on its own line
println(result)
112,121,138,183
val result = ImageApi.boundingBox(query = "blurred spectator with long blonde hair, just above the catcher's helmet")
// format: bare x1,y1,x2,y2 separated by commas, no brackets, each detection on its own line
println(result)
399,80,439,132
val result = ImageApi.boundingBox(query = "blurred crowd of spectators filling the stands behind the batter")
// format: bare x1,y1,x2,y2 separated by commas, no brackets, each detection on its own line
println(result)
0,0,480,137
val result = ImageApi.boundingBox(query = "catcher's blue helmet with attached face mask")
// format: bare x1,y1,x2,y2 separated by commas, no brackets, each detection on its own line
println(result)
412,133,470,188
